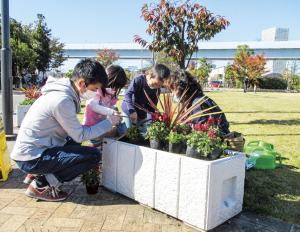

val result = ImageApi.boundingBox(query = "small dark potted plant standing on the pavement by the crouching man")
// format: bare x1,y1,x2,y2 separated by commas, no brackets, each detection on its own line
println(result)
81,165,100,194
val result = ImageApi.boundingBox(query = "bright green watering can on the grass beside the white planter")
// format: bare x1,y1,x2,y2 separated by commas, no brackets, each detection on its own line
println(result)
244,141,281,169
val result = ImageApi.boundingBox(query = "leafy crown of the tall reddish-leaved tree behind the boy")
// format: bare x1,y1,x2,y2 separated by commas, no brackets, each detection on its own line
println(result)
134,0,229,69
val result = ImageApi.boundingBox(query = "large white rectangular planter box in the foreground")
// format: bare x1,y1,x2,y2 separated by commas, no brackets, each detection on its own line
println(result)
102,139,245,230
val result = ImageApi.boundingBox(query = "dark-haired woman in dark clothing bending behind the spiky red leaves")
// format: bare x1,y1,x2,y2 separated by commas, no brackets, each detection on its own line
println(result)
166,70,230,135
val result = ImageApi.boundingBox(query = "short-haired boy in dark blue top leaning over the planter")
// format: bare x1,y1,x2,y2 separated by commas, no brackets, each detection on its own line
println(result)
122,64,170,128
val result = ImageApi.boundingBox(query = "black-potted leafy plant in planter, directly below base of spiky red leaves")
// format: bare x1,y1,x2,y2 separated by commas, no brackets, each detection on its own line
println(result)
146,121,170,149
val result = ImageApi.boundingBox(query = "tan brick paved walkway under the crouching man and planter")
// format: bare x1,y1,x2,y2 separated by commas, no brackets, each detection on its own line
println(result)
0,142,300,232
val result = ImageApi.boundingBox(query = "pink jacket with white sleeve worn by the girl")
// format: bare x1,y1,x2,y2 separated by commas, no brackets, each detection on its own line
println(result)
82,88,118,126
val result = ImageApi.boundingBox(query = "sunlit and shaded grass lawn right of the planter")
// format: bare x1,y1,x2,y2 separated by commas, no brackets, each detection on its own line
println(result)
79,92,300,224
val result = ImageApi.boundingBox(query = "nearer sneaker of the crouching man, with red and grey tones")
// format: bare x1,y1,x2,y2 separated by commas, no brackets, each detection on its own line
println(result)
25,180,68,201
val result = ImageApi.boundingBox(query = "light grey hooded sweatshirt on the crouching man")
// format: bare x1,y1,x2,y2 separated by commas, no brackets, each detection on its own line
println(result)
11,77,112,161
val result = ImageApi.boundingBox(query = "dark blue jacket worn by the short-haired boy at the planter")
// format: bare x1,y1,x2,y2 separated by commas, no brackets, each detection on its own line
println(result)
122,75,160,120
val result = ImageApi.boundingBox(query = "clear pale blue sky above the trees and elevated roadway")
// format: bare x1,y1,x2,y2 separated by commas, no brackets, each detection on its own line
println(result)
10,0,300,43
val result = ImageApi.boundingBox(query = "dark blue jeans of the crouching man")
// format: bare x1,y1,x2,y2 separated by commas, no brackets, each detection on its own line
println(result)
16,139,101,183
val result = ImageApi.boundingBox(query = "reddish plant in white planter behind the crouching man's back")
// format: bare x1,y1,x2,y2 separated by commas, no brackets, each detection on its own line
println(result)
17,86,41,127
